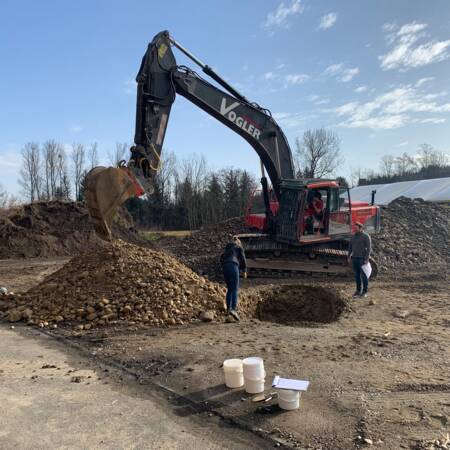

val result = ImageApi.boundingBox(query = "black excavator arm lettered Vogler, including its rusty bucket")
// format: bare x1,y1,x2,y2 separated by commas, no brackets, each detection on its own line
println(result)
87,31,294,237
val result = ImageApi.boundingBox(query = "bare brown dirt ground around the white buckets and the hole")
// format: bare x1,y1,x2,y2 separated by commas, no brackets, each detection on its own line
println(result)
0,260,450,449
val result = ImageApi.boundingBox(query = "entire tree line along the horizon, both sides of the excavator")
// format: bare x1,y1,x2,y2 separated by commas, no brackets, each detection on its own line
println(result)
11,128,450,229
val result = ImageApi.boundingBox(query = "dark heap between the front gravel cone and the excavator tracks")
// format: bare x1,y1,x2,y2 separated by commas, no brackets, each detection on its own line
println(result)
157,217,249,278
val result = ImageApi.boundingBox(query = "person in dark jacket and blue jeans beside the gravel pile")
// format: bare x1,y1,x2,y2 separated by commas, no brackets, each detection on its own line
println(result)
220,237,247,320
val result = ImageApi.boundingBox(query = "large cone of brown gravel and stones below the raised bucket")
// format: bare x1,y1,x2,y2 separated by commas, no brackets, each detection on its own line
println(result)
3,240,264,329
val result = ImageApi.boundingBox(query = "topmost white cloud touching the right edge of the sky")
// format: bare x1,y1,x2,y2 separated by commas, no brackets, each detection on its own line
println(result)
378,22,450,70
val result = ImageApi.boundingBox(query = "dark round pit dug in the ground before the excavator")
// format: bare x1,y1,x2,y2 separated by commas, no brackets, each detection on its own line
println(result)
255,285,347,325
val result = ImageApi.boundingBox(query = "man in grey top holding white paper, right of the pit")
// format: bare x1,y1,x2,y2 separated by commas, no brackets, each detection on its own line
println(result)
348,222,372,297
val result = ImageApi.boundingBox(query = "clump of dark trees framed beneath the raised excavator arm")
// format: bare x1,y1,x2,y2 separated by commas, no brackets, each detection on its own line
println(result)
125,152,258,230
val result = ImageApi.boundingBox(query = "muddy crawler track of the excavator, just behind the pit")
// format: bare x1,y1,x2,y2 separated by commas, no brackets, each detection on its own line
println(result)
238,234,378,278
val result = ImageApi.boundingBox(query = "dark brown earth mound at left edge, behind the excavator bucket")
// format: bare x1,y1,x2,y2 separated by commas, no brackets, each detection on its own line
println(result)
0,201,145,259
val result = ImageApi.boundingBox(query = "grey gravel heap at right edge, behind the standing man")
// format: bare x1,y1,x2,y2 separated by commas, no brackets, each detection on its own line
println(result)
373,197,450,271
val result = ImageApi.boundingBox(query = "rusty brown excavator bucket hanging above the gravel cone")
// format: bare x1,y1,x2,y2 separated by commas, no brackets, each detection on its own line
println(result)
86,166,137,240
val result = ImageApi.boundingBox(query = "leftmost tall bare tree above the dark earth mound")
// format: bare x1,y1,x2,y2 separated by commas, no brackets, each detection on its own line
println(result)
19,142,42,202
